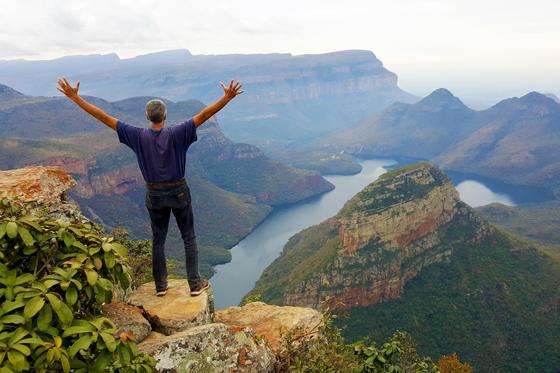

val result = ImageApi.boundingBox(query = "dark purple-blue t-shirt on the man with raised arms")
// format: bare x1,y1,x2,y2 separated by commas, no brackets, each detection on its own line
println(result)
117,118,197,183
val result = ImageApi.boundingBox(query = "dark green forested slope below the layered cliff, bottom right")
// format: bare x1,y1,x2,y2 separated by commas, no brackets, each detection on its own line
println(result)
337,232,560,372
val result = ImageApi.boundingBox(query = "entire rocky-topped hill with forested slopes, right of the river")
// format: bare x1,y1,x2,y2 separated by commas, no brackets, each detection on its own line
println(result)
250,163,560,372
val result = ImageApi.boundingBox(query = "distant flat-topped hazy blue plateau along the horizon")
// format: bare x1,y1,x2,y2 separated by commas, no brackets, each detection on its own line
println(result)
0,50,415,151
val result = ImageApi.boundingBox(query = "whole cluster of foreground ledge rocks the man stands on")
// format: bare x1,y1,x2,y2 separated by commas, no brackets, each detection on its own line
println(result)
103,280,322,373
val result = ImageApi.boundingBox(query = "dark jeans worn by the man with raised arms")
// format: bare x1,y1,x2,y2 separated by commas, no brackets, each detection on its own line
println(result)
146,184,200,291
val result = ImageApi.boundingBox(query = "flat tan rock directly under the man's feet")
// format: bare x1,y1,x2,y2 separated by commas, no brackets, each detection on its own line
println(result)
127,279,214,335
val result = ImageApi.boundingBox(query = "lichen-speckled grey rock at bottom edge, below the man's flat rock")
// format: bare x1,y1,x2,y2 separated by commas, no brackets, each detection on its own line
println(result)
139,323,275,373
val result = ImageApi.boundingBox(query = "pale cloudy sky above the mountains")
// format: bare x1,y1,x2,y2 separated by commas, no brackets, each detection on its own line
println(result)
0,0,560,107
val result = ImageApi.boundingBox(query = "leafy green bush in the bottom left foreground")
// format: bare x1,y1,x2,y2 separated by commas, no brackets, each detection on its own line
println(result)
0,199,154,373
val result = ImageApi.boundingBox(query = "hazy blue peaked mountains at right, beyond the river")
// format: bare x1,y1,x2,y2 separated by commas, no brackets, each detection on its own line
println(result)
322,89,560,195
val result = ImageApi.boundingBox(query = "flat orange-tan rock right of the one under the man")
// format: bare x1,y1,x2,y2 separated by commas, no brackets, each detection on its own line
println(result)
214,302,323,354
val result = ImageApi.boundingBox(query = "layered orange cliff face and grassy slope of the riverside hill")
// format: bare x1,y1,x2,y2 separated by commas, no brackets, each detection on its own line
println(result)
249,164,491,308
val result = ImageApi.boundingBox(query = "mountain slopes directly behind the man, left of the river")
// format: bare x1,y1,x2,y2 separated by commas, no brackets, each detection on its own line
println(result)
0,85,333,275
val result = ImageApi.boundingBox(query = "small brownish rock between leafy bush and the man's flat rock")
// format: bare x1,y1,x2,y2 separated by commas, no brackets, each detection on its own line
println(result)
101,302,152,342
